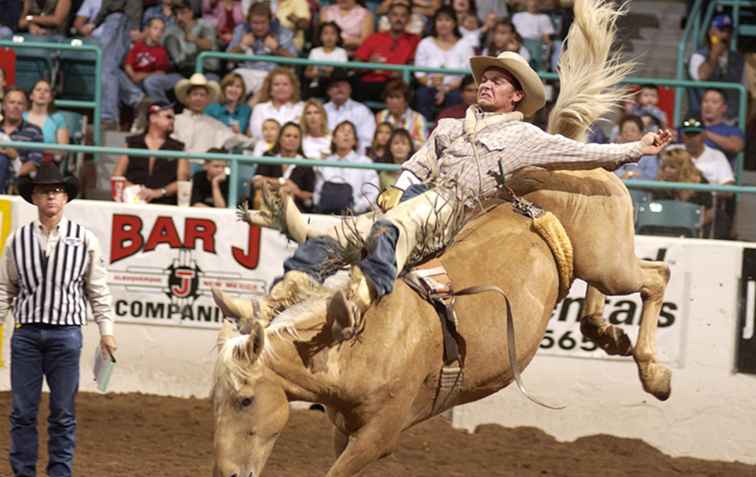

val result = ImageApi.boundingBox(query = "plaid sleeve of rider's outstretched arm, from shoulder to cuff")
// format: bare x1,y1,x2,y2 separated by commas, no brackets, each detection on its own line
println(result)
520,124,642,170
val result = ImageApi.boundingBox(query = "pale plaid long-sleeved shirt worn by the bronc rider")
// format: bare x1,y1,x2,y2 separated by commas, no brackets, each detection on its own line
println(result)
402,106,641,205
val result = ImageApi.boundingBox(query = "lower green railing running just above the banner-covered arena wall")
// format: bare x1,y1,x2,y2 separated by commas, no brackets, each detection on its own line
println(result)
8,142,756,207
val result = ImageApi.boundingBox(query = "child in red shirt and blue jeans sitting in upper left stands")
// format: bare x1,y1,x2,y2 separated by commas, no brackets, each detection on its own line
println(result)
119,17,182,113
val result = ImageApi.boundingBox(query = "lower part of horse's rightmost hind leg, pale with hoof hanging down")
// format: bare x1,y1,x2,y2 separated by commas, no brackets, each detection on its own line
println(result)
633,260,672,401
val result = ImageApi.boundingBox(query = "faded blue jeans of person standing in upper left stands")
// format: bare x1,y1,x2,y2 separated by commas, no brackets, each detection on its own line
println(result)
97,13,131,122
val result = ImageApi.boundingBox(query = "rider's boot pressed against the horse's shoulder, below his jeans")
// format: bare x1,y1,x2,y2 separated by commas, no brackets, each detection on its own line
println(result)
327,265,377,341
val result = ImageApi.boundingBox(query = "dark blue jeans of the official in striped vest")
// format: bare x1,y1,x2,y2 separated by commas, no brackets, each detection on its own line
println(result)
10,325,82,477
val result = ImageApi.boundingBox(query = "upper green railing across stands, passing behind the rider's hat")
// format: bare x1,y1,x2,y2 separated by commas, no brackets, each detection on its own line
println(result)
195,52,748,184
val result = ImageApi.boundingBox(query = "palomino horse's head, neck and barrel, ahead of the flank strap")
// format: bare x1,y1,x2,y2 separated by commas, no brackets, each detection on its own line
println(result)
212,205,559,477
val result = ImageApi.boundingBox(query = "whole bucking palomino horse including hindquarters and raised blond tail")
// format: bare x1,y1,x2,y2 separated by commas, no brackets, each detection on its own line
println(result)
212,0,671,477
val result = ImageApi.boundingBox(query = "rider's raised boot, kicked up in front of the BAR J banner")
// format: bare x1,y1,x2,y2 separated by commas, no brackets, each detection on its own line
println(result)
238,183,310,243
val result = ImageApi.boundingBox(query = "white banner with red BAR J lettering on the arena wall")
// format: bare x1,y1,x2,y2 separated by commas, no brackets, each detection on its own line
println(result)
66,202,302,327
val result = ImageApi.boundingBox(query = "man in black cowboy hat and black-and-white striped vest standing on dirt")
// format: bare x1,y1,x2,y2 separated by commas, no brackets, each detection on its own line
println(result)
0,164,116,477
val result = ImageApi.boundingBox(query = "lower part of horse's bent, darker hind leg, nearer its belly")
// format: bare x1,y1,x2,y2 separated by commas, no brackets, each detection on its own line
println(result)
580,285,633,356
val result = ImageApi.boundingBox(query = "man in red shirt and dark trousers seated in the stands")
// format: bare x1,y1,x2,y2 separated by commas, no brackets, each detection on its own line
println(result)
354,2,420,101
